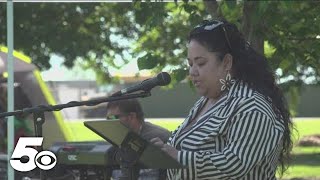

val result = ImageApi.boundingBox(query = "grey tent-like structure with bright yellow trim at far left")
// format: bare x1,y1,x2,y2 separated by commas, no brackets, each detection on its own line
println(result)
0,46,72,147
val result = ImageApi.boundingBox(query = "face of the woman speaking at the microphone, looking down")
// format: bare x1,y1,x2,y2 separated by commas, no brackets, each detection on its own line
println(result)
188,40,226,99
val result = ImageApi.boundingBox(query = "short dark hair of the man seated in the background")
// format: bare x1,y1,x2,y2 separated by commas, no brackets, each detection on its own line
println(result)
107,99,144,122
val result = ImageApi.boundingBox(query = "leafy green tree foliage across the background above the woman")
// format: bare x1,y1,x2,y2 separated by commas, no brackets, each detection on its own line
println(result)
0,0,320,114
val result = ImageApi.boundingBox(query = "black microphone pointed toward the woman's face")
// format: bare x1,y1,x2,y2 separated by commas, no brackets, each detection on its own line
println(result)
111,72,171,97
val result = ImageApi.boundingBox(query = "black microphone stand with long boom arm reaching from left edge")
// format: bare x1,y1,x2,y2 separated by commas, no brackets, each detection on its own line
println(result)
0,90,151,180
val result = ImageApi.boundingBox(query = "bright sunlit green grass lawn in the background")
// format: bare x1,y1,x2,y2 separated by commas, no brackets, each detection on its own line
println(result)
66,118,320,178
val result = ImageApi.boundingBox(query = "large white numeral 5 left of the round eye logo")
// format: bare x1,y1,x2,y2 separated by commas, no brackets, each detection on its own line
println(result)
10,137,43,172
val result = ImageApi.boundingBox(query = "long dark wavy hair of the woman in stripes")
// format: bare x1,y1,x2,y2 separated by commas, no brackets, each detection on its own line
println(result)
188,20,293,175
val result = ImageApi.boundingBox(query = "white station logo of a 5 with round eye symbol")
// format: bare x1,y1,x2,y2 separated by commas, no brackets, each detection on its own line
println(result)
10,137,57,172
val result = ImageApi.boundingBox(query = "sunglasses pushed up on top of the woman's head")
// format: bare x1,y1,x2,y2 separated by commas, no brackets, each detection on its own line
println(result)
193,20,232,51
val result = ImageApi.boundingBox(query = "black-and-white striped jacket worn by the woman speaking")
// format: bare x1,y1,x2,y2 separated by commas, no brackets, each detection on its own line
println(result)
167,81,284,180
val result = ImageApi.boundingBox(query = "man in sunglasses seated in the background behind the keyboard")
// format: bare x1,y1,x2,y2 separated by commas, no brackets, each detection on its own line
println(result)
107,99,171,180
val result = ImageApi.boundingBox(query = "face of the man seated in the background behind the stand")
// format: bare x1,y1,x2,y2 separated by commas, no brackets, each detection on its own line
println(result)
107,107,140,132
